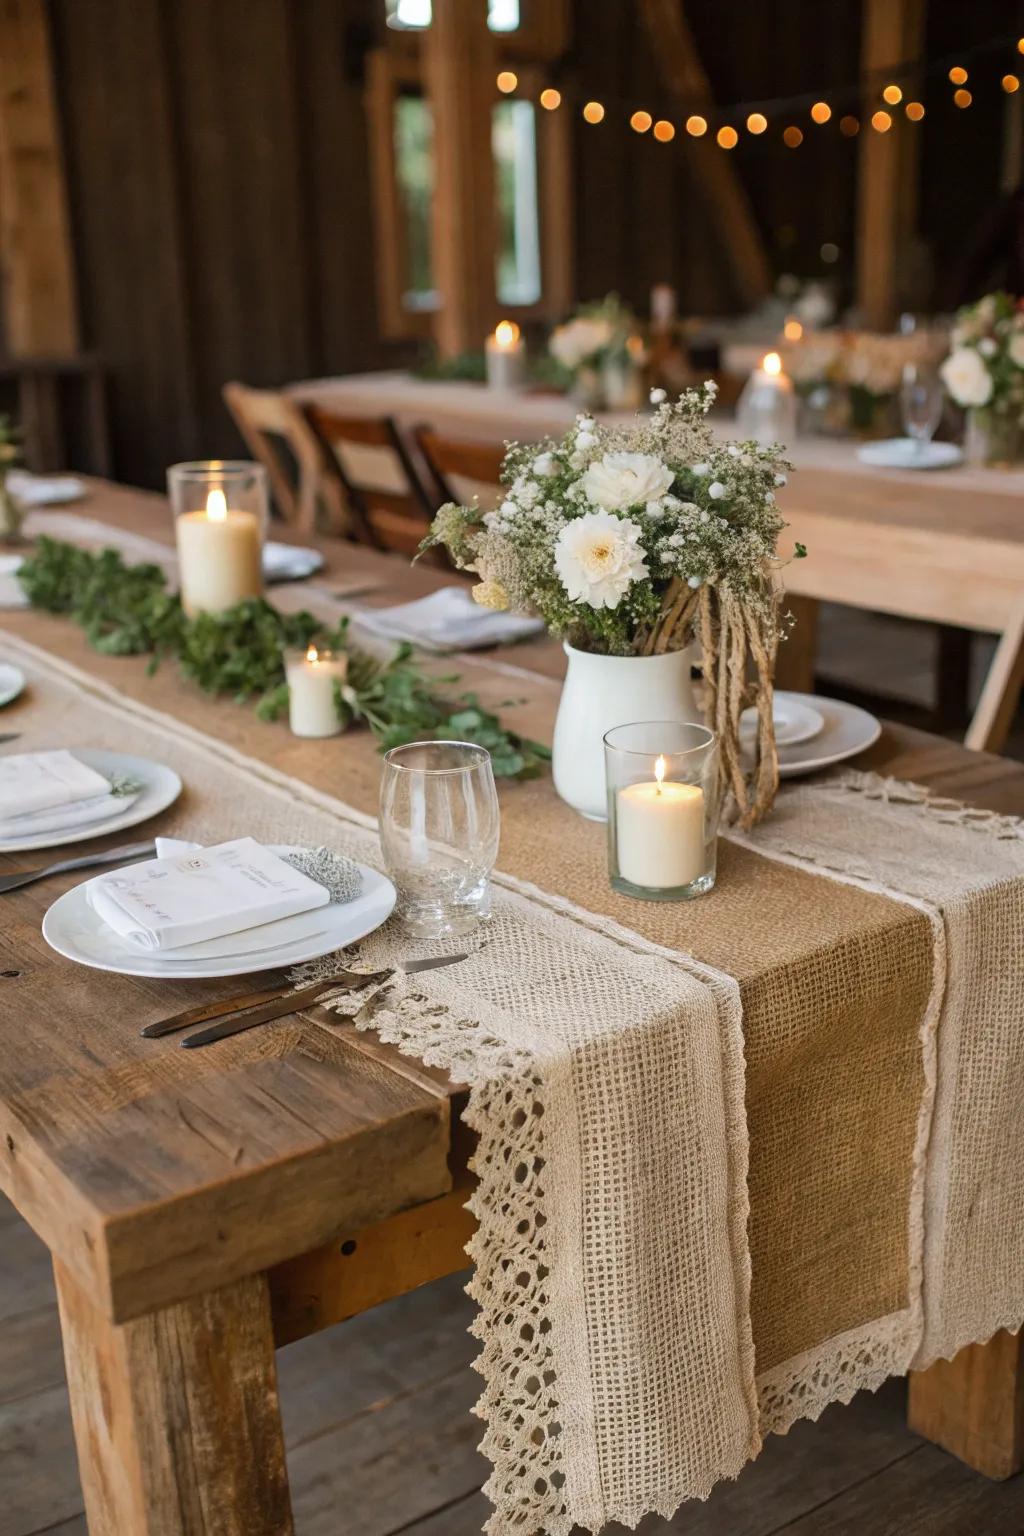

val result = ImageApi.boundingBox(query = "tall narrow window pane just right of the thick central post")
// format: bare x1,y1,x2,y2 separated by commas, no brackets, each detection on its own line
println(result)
491,101,540,304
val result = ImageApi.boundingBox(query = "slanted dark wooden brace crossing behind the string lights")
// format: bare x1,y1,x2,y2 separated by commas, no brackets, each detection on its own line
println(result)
640,0,772,306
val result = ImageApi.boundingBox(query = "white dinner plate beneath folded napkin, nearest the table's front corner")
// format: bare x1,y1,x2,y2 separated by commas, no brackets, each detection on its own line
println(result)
43,845,395,982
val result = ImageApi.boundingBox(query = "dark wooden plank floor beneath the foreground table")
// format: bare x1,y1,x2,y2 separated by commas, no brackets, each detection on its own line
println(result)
0,1197,1024,1536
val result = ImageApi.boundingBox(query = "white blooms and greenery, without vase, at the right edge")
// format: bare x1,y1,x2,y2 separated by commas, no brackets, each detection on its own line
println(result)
941,293,1024,427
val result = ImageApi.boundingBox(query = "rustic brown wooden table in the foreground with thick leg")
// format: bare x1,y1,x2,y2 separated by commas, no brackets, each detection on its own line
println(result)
0,482,1024,1536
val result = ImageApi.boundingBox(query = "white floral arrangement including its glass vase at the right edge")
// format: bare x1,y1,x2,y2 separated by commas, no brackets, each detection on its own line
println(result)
941,293,1024,464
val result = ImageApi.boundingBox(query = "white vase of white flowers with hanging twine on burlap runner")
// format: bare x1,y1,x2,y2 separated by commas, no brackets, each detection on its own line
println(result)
425,382,789,826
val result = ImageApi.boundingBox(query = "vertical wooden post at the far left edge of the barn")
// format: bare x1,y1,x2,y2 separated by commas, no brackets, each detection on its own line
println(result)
0,0,78,358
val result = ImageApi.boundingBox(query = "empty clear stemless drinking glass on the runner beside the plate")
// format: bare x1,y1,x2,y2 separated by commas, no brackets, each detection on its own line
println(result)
381,742,500,938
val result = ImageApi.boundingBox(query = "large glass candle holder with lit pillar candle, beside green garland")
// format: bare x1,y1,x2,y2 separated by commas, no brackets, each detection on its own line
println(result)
167,459,269,617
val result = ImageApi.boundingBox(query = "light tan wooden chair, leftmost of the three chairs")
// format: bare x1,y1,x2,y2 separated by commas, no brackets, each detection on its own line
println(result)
221,382,348,533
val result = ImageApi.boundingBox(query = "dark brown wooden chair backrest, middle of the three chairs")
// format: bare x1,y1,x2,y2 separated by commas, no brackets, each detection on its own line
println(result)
306,406,434,554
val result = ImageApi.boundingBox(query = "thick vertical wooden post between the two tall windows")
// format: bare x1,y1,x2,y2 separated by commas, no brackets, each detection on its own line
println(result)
424,0,497,356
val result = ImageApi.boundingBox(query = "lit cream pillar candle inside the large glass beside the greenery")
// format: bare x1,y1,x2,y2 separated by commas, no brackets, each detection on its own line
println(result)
175,488,263,616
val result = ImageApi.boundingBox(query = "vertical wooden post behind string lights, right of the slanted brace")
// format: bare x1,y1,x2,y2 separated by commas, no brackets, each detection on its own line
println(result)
857,0,924,330
